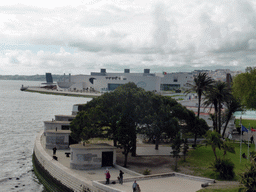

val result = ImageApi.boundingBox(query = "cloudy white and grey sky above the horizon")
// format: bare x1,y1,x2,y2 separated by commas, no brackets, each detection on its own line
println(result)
0,0,256,75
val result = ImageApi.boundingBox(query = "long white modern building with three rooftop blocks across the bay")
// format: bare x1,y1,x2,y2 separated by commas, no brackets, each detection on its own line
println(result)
57,69,193,92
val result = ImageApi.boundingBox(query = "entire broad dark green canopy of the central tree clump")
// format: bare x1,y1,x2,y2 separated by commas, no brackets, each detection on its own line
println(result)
70,83,205,166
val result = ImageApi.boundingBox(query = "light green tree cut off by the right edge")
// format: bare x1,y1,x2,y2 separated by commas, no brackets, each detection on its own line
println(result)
232,67,256,109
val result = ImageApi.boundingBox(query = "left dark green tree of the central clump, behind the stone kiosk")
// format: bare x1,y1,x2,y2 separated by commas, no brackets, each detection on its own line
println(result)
72,83,145,160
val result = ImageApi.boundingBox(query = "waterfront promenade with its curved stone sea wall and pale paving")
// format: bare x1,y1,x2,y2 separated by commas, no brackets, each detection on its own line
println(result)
35,131,214,192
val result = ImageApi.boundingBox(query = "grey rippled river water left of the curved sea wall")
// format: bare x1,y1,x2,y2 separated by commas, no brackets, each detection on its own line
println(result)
0,80,91,192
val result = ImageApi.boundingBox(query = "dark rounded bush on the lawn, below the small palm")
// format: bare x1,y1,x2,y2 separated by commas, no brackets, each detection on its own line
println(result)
212,158,235,180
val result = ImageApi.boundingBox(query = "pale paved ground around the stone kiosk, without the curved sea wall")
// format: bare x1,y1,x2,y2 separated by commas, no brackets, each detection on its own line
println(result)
41,137,214,192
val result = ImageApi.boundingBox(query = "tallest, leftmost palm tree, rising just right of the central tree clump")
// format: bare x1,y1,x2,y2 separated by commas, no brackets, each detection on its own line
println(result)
185,73,213,117
